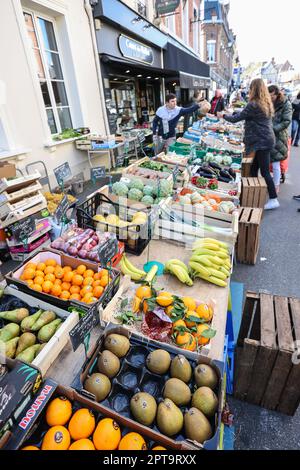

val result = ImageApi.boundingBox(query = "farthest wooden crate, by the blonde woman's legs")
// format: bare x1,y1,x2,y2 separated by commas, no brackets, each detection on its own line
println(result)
241,178,268,209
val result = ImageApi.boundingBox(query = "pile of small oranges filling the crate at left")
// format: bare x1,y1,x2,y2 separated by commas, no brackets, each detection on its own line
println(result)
20,258,111,304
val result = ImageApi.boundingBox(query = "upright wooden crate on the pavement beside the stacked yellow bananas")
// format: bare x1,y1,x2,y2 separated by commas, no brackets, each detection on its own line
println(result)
236,207,263,264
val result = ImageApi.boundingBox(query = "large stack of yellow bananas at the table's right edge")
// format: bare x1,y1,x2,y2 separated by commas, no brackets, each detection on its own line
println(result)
189,238,231,287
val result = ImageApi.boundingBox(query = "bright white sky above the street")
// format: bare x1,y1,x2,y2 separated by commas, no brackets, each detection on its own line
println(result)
229,0,300,72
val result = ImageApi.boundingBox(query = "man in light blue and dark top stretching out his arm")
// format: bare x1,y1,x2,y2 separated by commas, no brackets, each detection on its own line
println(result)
152,93,203,153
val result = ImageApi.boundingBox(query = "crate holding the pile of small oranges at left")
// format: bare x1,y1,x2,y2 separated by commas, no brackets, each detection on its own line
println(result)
5,248,120,311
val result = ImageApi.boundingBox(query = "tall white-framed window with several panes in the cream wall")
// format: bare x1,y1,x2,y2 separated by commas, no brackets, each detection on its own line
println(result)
24,12,72,134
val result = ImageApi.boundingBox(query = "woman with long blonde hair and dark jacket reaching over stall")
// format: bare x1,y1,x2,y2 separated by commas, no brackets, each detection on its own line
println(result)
218,78,279,210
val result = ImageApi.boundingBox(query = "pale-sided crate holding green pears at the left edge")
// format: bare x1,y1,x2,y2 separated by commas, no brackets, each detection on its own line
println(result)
0,287,79,376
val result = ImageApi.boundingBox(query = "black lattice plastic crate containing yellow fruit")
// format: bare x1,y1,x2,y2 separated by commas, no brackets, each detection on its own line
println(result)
76,193,158,254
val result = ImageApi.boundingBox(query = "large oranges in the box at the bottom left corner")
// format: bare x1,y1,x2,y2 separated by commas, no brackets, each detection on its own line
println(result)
21,397,166,450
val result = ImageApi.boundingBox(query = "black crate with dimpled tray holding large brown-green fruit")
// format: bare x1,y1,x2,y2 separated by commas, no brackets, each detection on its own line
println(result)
72,324,224,450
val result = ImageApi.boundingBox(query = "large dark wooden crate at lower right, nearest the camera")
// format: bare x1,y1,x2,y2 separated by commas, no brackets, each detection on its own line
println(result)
234,292,300,416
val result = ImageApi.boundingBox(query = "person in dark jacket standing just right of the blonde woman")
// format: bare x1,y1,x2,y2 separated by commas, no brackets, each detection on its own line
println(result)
268,85,293,194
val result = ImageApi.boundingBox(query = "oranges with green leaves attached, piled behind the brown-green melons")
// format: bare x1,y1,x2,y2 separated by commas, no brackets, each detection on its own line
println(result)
132,286,216,351
